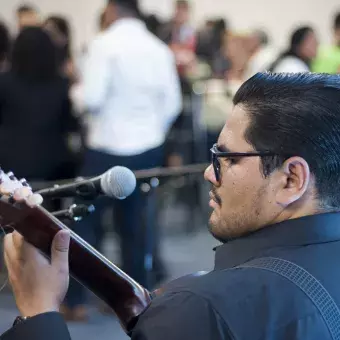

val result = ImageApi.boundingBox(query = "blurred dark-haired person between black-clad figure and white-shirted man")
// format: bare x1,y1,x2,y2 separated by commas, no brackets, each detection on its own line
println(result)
44,16,77,82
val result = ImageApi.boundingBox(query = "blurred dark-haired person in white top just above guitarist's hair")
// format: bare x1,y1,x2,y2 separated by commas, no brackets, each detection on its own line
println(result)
269,26,318,73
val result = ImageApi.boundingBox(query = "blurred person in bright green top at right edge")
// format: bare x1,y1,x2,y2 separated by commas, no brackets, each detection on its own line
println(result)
312,12,340,74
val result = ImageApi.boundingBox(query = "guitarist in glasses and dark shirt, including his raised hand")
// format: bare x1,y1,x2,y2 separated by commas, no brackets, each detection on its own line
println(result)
4,73,340,340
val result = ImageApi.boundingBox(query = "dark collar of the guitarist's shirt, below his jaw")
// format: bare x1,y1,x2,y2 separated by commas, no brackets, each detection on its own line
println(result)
215,213,340,270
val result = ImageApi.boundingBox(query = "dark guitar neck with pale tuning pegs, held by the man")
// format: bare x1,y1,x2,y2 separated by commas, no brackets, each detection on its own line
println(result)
0,171,153,335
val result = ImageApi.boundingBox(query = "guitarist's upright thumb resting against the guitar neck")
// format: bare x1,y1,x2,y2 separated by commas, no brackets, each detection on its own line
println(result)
51,230,71,272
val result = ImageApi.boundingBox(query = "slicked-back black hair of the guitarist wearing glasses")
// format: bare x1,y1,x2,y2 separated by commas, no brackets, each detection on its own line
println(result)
234,73,340,210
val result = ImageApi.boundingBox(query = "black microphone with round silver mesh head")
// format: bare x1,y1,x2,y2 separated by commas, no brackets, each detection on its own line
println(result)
37,166,137,200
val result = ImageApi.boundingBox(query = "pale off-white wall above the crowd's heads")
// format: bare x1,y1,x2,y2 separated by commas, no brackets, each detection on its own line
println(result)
0,0,340,51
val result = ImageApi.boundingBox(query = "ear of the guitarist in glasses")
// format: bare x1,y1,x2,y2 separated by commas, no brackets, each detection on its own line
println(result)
276,157,311,206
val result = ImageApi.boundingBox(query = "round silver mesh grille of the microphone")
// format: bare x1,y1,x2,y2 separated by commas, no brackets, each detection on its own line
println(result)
100,166,137,200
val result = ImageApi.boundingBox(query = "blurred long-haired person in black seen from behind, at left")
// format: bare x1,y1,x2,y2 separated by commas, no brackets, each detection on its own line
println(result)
0,27,72,181
